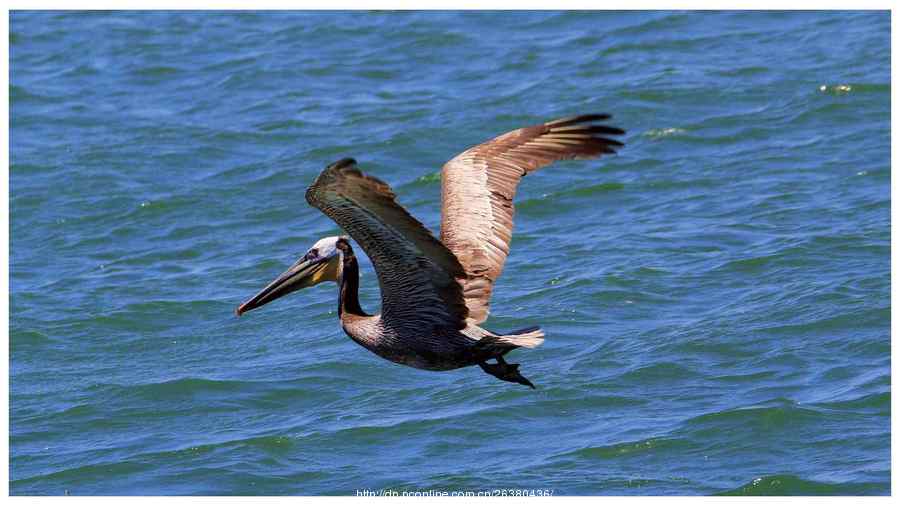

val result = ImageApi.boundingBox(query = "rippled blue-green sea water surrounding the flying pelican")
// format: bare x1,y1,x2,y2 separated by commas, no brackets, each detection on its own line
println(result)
9,11,891,495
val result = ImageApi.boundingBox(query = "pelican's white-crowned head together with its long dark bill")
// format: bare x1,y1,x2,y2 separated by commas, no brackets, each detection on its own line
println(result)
235,236,348,316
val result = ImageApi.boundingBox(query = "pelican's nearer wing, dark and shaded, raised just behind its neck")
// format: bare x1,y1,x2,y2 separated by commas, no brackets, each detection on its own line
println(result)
306,158,467,334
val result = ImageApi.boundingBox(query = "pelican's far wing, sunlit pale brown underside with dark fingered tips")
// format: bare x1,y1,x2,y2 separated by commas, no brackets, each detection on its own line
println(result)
441,114,625,323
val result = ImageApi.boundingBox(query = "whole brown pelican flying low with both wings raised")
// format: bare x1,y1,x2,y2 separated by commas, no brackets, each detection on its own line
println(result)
236,114,625,388
